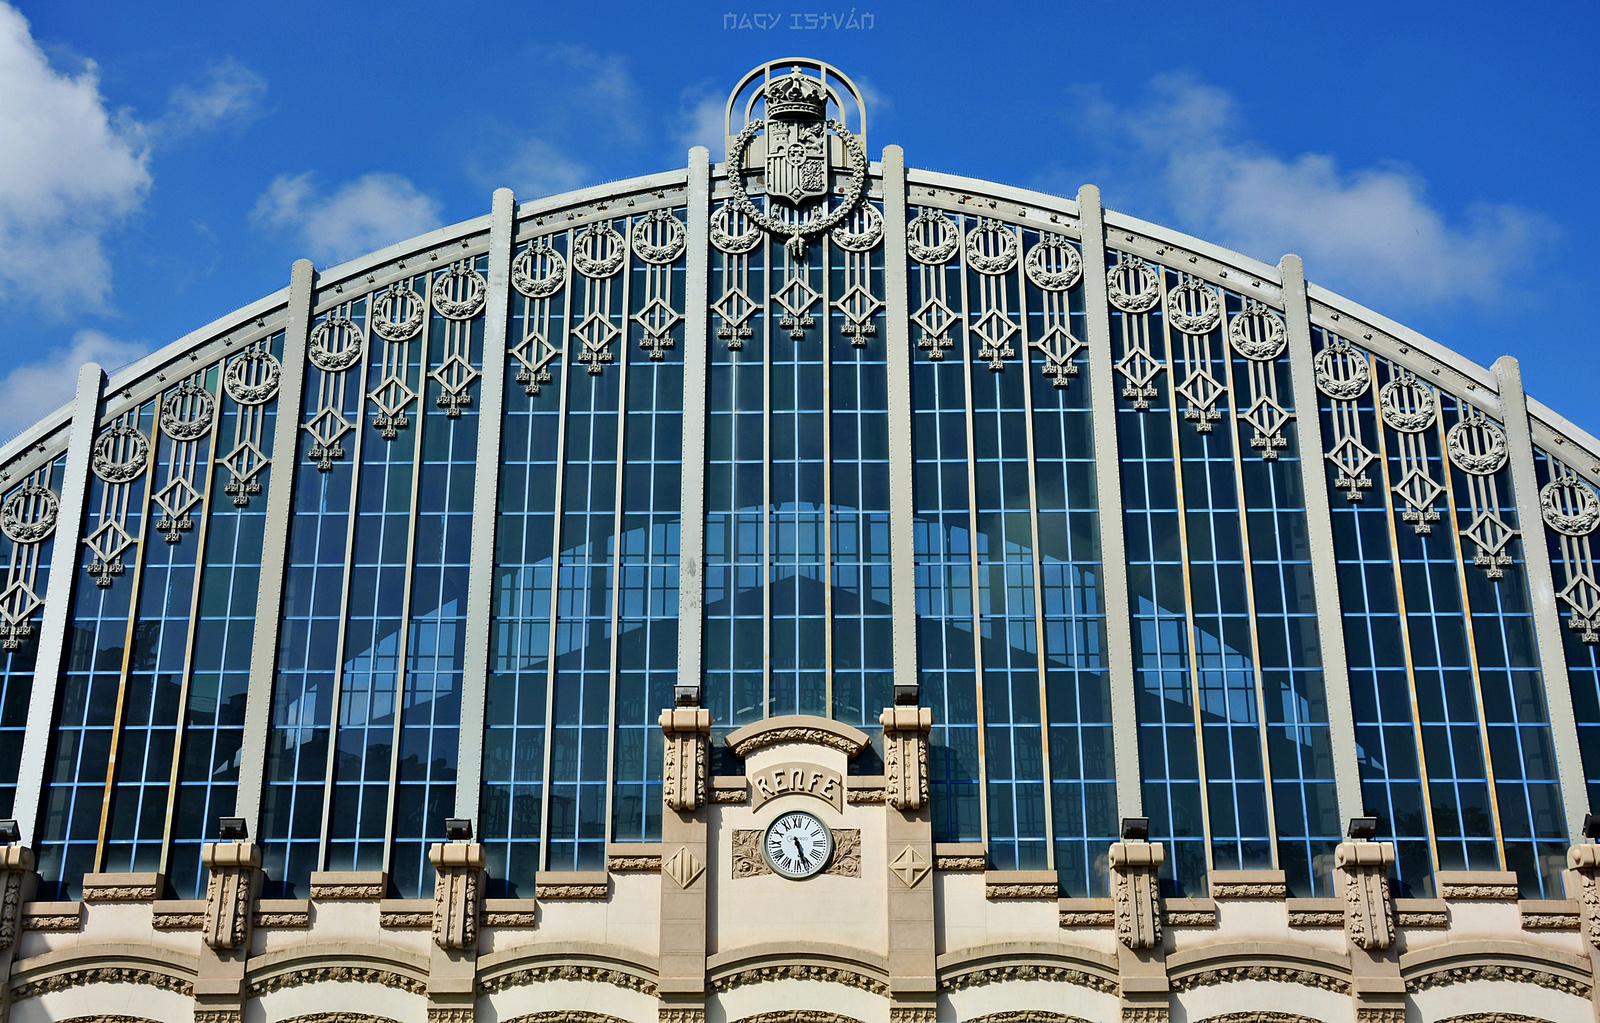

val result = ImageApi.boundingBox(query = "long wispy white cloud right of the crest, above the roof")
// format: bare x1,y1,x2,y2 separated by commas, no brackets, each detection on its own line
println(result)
1083,75,1554,307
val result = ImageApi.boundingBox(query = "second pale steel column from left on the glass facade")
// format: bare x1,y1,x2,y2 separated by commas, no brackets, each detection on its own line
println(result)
234,259,317,837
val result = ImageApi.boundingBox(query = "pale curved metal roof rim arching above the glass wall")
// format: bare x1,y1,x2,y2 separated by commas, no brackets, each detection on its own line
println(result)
0,162,1600,477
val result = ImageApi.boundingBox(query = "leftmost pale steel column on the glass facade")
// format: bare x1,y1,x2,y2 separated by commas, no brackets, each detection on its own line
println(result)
11,362,106,845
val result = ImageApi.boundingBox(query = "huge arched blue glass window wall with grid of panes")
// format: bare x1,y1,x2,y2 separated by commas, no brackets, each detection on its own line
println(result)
0,156,1600,898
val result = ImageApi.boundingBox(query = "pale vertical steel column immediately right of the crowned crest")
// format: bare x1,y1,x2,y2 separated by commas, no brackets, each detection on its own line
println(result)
883,146,922,709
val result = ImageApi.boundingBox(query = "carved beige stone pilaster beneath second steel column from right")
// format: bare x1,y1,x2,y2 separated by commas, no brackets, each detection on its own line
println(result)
1333,842,1405,1023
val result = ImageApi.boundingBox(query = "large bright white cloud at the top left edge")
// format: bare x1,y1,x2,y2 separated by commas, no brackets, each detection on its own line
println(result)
0,2,150,312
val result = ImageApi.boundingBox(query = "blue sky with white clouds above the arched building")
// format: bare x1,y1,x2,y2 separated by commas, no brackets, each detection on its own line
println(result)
0,0,1600,440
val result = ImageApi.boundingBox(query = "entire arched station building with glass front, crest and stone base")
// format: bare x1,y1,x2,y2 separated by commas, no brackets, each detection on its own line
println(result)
0,61,1600,1023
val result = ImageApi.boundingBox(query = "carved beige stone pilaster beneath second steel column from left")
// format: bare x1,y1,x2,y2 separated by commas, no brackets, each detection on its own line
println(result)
195,842,261,1023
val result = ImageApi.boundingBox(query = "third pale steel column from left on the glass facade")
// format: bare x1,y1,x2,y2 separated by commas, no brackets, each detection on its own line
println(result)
456,189,517,821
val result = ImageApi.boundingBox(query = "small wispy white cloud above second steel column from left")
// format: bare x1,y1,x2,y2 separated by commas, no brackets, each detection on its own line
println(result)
250,171,440,263
